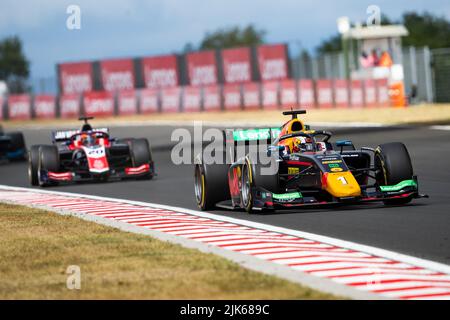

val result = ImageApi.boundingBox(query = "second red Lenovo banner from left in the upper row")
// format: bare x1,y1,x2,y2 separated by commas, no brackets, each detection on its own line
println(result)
100,59,134,91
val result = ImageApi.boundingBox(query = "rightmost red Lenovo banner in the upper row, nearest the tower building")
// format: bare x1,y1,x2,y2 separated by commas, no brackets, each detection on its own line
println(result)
257,44,288,81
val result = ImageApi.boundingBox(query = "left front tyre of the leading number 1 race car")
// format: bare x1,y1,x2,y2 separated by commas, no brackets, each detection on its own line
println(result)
241,154,280,213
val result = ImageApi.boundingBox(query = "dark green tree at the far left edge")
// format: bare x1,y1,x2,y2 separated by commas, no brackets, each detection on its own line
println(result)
0,36,30,93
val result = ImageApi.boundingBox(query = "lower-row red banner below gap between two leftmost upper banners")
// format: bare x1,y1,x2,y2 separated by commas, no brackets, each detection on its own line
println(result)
83,91,114,117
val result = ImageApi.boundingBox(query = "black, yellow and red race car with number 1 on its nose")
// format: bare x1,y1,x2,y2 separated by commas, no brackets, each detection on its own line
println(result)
194,110,427,212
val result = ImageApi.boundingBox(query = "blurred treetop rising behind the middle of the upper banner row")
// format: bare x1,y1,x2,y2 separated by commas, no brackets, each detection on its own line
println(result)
200,25,266,50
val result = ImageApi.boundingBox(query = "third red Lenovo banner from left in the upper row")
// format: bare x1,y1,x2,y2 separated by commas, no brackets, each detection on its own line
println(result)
141,55,178,88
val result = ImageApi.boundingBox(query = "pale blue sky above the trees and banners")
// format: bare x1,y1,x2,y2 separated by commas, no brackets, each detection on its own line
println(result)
0,0,450,78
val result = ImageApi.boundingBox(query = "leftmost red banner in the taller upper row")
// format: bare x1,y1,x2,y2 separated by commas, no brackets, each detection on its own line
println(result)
59,62,94,94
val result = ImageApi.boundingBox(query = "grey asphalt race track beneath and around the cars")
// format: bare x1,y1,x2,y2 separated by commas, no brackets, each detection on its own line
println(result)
0,127,450,264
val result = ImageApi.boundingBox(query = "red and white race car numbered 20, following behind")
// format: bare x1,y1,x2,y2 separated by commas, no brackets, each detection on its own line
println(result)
28,117,155,187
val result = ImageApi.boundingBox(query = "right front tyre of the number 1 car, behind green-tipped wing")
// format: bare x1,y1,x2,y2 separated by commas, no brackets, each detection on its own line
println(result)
374,142,414,205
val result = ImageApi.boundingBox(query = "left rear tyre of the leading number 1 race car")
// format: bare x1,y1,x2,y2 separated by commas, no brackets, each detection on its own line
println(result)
194,163,230,211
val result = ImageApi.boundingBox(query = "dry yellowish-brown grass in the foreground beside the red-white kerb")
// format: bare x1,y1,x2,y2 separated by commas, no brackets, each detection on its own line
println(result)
0,204,336,299
